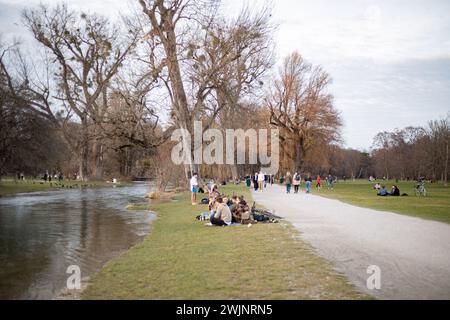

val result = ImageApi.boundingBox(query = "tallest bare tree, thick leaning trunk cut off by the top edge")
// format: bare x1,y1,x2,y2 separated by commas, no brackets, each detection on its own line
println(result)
139,0,274,182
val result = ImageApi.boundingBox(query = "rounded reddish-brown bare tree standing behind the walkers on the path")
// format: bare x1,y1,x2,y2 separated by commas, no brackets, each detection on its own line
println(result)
266,52,341,170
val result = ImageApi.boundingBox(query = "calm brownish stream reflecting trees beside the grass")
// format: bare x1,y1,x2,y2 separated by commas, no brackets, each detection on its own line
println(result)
0,183,154,299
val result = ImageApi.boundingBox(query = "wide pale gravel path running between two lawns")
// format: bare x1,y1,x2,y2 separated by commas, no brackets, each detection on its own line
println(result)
253,185,450,299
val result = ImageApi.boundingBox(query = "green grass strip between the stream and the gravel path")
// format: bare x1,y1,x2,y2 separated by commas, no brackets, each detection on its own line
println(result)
82,186,367,299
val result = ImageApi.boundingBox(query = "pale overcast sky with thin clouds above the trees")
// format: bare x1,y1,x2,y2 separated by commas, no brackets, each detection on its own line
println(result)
0,0,450,149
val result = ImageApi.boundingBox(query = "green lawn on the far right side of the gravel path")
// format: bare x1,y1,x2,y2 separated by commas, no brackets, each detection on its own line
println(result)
312,180,450,223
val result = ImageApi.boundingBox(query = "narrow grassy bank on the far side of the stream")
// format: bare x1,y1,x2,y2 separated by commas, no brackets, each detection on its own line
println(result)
0,178,126,197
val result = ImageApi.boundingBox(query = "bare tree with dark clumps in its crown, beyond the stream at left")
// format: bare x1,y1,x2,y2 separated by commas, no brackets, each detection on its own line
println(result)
23,5,139,179
